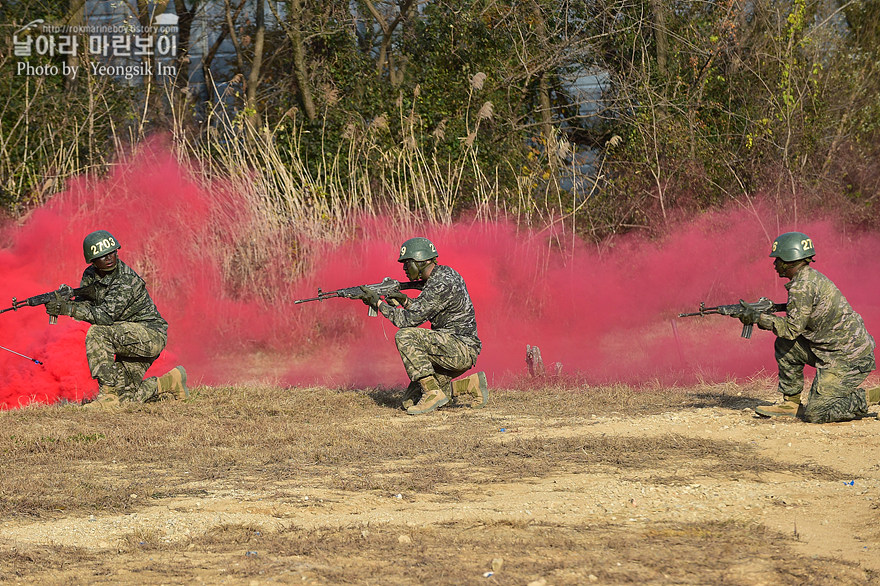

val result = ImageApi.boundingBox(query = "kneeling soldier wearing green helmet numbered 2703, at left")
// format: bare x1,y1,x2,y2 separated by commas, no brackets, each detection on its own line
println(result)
46,230,188,407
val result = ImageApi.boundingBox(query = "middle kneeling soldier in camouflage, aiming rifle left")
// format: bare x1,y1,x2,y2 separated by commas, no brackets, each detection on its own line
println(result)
361,238,489,415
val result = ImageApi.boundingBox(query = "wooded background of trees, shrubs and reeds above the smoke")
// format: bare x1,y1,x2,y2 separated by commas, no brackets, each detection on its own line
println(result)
0,0,880,238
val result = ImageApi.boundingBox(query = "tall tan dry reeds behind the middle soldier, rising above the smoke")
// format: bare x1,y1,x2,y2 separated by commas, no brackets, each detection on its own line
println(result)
170,94,508,297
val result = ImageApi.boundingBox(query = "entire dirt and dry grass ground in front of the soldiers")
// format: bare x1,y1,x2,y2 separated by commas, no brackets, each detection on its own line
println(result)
0,381,880,586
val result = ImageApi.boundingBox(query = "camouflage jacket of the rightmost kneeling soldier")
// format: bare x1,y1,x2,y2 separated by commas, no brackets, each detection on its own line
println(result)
758,266,874,367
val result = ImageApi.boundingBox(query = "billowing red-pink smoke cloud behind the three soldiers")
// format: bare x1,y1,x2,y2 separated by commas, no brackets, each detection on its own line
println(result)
0,145,880,408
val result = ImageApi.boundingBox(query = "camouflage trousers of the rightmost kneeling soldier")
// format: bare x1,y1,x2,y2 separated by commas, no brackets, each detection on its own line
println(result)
775,336,875,423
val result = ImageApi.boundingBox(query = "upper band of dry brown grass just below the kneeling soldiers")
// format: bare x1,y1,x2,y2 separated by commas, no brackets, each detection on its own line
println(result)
0,386,834,516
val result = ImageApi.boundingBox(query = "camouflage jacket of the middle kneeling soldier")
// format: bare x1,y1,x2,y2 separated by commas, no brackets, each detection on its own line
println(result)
379,265,482,354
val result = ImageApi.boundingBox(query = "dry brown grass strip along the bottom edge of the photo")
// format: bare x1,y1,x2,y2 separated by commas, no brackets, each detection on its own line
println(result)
0,522,864,585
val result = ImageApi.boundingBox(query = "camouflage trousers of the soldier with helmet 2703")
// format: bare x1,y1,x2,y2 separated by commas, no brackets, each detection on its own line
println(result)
86,322,168,403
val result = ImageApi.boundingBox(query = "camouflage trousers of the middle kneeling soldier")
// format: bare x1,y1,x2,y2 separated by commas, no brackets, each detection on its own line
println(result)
394,328,477,394
